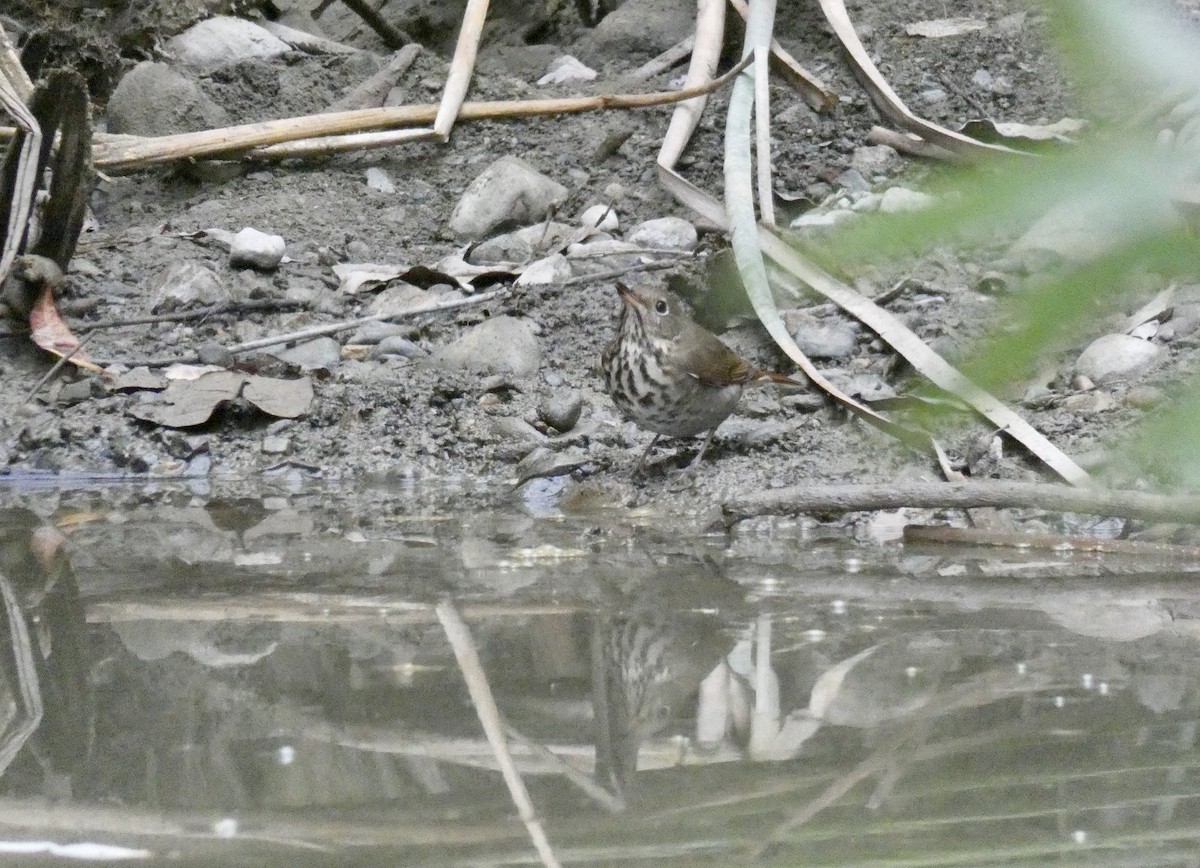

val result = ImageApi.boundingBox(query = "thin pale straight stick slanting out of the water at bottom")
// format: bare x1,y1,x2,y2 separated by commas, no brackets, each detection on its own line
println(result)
437,600,558,868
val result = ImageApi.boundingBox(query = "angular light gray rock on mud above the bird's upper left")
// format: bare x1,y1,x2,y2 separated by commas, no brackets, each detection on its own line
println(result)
450,155,568,241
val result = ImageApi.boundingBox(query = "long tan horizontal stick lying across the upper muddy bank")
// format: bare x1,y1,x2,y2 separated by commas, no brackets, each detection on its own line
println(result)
94,60,749,172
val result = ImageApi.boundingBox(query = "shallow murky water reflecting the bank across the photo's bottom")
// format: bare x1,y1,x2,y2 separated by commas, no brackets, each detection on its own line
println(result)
0,485,1200,866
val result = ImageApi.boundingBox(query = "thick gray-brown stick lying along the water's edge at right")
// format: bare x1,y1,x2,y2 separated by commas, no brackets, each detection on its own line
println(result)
724,483,1200,522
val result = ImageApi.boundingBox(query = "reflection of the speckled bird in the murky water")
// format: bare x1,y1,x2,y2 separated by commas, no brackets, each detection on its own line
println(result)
592,600,732,792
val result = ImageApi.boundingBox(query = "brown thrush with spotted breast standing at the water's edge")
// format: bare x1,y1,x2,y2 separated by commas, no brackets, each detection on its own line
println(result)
600,283,803,474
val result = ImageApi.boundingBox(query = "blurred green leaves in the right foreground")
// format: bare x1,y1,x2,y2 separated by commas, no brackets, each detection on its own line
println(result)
806,0,1200,484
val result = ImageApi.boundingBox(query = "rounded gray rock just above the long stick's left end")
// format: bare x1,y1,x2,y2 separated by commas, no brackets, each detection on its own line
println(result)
108,60,230,136
